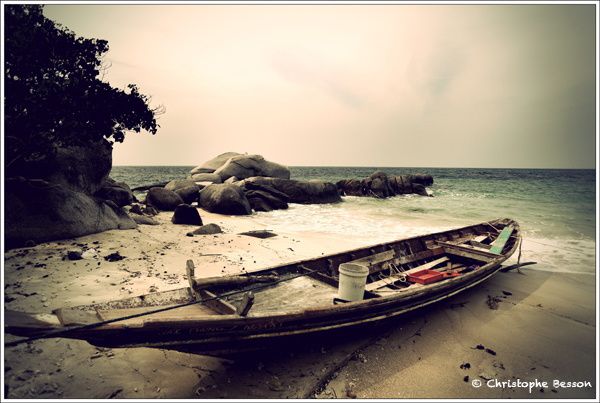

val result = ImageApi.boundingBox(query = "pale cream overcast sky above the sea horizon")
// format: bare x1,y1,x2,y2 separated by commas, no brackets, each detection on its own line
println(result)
45,5,596,168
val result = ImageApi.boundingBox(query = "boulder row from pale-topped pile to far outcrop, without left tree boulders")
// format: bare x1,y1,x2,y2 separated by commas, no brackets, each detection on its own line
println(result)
129,152,433,224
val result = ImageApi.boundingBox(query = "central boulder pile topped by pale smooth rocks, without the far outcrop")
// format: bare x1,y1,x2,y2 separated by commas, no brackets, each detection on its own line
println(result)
130,152,342,229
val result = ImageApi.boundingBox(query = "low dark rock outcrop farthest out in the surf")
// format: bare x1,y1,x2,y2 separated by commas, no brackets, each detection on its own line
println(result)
336,171,433,199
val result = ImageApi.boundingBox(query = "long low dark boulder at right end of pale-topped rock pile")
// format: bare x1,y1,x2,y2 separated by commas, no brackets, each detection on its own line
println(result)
240,176,342,204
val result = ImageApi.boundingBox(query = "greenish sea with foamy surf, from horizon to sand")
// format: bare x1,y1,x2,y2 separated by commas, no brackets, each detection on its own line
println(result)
111,166,596,274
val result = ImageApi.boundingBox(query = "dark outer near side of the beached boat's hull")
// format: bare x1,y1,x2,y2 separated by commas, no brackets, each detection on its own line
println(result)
72,258,500,355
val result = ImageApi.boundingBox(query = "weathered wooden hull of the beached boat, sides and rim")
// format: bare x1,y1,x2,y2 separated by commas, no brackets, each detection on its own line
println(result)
5,219,520,355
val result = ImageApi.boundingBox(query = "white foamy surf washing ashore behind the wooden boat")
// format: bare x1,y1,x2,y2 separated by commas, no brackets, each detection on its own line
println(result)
244,197,595,273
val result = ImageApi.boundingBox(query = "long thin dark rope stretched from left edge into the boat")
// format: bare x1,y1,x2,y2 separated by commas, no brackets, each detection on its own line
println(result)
4,269,318,347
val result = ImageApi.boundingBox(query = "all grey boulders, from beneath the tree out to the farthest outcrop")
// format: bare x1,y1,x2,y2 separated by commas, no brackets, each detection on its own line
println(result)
5,148,433,248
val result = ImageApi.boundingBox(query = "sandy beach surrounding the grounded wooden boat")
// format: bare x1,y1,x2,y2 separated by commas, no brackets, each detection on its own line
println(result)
4,212,596,399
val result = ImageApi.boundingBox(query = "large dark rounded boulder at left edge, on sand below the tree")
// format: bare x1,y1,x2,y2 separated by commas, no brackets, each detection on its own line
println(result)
4,178,137,248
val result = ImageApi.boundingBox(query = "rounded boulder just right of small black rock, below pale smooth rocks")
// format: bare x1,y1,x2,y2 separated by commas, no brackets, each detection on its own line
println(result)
198,184,252,215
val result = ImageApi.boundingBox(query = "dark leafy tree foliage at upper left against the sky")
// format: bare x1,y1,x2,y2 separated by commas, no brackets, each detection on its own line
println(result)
4,4,158,174
